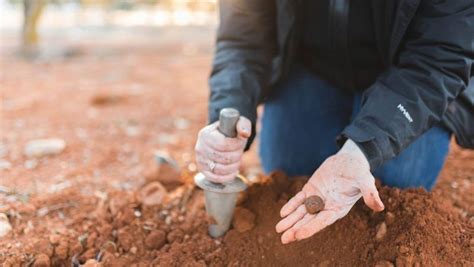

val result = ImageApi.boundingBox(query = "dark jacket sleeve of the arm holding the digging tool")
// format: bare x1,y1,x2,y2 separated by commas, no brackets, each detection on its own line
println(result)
209,0,276,149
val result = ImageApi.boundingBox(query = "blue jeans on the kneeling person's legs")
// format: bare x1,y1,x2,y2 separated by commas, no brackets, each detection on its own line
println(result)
260,67,450,190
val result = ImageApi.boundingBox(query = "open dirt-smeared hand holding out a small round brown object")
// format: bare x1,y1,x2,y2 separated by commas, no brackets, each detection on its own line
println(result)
276,139,384,244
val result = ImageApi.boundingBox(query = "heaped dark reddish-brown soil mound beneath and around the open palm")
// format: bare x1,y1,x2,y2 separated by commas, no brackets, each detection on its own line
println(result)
224,175,474,266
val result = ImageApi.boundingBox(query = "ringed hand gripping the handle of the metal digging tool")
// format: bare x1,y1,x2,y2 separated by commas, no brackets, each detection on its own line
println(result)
194,116,252,183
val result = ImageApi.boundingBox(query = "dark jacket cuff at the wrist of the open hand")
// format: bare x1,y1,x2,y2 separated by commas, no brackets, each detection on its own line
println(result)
336,124,391,171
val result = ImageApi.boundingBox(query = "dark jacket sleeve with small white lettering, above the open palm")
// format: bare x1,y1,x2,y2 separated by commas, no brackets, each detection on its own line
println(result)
339,0,474,170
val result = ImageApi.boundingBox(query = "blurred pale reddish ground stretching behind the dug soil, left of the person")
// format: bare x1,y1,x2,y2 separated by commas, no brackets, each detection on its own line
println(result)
0,27,262,194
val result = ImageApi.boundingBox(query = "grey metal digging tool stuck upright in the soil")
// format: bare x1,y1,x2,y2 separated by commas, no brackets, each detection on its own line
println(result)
194,108,247,238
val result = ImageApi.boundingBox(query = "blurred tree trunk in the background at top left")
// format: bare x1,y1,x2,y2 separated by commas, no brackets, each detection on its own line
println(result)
22,0,45,52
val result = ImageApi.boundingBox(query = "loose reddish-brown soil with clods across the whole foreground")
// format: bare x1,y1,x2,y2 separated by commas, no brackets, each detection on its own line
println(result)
0,173,474,266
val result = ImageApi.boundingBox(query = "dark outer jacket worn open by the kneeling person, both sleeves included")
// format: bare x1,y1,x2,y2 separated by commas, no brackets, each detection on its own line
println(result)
209,0,474,169
